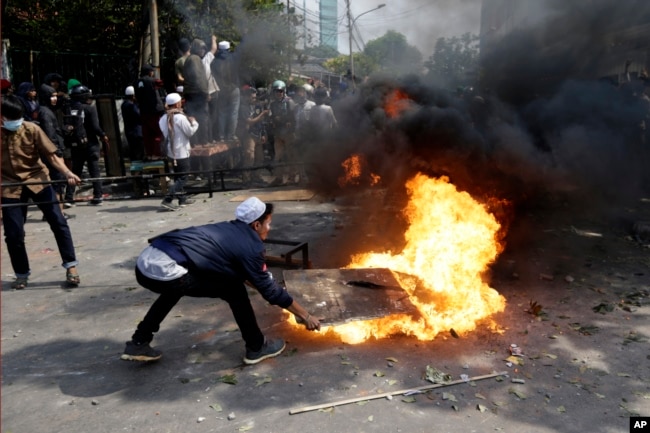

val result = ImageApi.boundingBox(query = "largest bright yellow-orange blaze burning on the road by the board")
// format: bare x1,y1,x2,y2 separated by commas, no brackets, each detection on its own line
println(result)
310,174,505,344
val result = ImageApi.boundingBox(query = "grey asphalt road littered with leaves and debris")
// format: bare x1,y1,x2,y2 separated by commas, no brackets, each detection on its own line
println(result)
1,186,650,433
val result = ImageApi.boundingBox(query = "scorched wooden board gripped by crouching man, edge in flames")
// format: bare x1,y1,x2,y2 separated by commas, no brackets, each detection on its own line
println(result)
283,268,420,325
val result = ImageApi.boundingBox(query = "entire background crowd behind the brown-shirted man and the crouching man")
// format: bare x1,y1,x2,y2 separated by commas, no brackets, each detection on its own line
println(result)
2,36,337,211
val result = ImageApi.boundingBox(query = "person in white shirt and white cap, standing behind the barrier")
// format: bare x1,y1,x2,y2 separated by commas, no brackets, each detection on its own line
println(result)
158,93,199,210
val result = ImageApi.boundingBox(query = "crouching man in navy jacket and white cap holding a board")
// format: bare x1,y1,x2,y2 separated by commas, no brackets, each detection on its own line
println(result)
121,197,320,364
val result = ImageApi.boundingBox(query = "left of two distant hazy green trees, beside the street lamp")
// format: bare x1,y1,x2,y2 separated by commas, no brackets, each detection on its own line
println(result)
362,30,422,76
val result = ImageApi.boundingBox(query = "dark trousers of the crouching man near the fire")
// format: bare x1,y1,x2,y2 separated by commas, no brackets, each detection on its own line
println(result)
131,266,264,351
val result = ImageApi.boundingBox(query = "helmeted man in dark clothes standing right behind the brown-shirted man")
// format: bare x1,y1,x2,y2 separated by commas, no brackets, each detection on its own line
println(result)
65,84,108,206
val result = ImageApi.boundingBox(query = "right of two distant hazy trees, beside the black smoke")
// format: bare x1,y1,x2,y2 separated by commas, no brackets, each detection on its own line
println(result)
424,33,479,88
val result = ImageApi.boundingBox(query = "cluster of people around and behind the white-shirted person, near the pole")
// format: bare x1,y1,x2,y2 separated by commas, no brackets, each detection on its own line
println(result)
130,36,344,192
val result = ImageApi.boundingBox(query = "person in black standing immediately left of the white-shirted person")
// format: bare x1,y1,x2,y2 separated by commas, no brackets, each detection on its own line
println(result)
133,65,165,160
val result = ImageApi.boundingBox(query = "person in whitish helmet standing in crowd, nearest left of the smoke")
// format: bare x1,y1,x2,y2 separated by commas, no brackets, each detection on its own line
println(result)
270,80,296,183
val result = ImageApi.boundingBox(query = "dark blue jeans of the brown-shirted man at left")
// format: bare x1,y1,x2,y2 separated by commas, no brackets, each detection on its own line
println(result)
2,186,79,278
